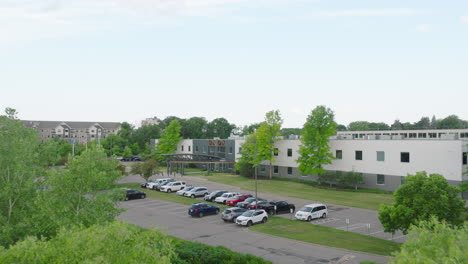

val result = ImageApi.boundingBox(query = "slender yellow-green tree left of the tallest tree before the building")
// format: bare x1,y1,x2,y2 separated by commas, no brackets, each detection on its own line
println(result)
255,110,283,179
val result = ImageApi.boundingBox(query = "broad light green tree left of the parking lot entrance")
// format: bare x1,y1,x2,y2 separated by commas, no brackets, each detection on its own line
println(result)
33,145,122,237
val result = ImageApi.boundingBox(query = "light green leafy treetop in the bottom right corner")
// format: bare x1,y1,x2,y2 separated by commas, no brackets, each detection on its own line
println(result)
390,217,468,264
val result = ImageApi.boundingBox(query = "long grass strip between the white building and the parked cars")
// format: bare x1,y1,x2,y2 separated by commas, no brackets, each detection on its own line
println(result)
188,174,393,210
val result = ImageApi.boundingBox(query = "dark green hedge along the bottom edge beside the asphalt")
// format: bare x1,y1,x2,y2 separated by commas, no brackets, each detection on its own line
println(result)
172,240,271,264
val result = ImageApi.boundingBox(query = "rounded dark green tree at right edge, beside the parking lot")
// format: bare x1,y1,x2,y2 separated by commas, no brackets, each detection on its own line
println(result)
379,172,465,234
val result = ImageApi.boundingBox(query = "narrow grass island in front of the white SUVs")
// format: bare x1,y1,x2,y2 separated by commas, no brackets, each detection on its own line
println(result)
250,216,401,256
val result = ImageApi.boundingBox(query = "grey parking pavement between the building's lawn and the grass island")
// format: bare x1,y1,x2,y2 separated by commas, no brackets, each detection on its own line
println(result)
123,175,406,242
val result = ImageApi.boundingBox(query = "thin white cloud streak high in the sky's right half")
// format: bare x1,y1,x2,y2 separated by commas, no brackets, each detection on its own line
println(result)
319,8,430,17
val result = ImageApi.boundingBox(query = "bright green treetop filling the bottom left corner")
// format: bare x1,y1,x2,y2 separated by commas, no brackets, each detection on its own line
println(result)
0,221,177,264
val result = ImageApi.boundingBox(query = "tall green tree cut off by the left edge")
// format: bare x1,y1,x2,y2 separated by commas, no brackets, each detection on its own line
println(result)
0,108,44,245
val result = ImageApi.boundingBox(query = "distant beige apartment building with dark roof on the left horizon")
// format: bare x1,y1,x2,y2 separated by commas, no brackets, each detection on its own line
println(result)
22,120,120,143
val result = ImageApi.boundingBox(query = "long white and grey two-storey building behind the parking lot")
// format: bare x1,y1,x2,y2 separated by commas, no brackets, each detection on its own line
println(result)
173,129,468,191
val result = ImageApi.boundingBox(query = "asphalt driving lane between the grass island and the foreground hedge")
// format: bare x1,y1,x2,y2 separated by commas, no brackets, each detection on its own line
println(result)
119,198,388,264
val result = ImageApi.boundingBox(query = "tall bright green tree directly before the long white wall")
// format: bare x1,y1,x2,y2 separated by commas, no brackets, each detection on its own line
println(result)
297,106,337,175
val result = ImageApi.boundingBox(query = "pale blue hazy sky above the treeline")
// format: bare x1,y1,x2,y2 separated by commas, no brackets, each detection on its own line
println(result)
0,0,468,127
